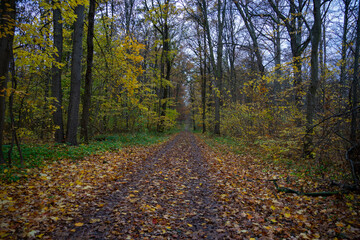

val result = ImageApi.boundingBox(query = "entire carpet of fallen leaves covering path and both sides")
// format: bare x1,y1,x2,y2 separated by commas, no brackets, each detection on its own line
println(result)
0,132,360,239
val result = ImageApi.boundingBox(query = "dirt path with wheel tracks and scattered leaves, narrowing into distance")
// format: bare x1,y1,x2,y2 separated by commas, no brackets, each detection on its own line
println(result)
57,132,236,239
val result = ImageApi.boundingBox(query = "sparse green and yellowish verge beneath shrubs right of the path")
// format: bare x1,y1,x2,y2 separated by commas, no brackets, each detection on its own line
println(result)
197,133,351,182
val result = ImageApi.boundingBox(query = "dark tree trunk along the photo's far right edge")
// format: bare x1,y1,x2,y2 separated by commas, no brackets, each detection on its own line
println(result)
350,2,360,145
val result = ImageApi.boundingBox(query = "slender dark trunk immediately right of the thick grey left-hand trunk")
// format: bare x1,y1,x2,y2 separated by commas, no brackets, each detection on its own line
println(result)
81,0,96,143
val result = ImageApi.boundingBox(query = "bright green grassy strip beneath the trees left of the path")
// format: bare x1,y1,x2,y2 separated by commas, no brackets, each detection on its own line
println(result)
0,132,174,182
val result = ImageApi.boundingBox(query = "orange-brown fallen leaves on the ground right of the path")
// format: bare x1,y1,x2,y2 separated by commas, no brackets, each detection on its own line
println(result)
201,135,360,239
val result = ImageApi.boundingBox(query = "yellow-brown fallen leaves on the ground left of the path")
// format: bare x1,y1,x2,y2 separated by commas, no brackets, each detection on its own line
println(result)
0,141,166,239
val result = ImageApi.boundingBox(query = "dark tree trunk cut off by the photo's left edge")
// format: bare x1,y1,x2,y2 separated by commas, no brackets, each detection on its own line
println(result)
0,0,16,164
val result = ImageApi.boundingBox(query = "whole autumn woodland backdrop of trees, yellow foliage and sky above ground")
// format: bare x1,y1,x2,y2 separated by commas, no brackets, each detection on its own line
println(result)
0,0,360,181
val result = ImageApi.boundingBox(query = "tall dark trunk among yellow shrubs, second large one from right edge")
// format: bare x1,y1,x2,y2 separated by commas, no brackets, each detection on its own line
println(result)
304,0,321,157
